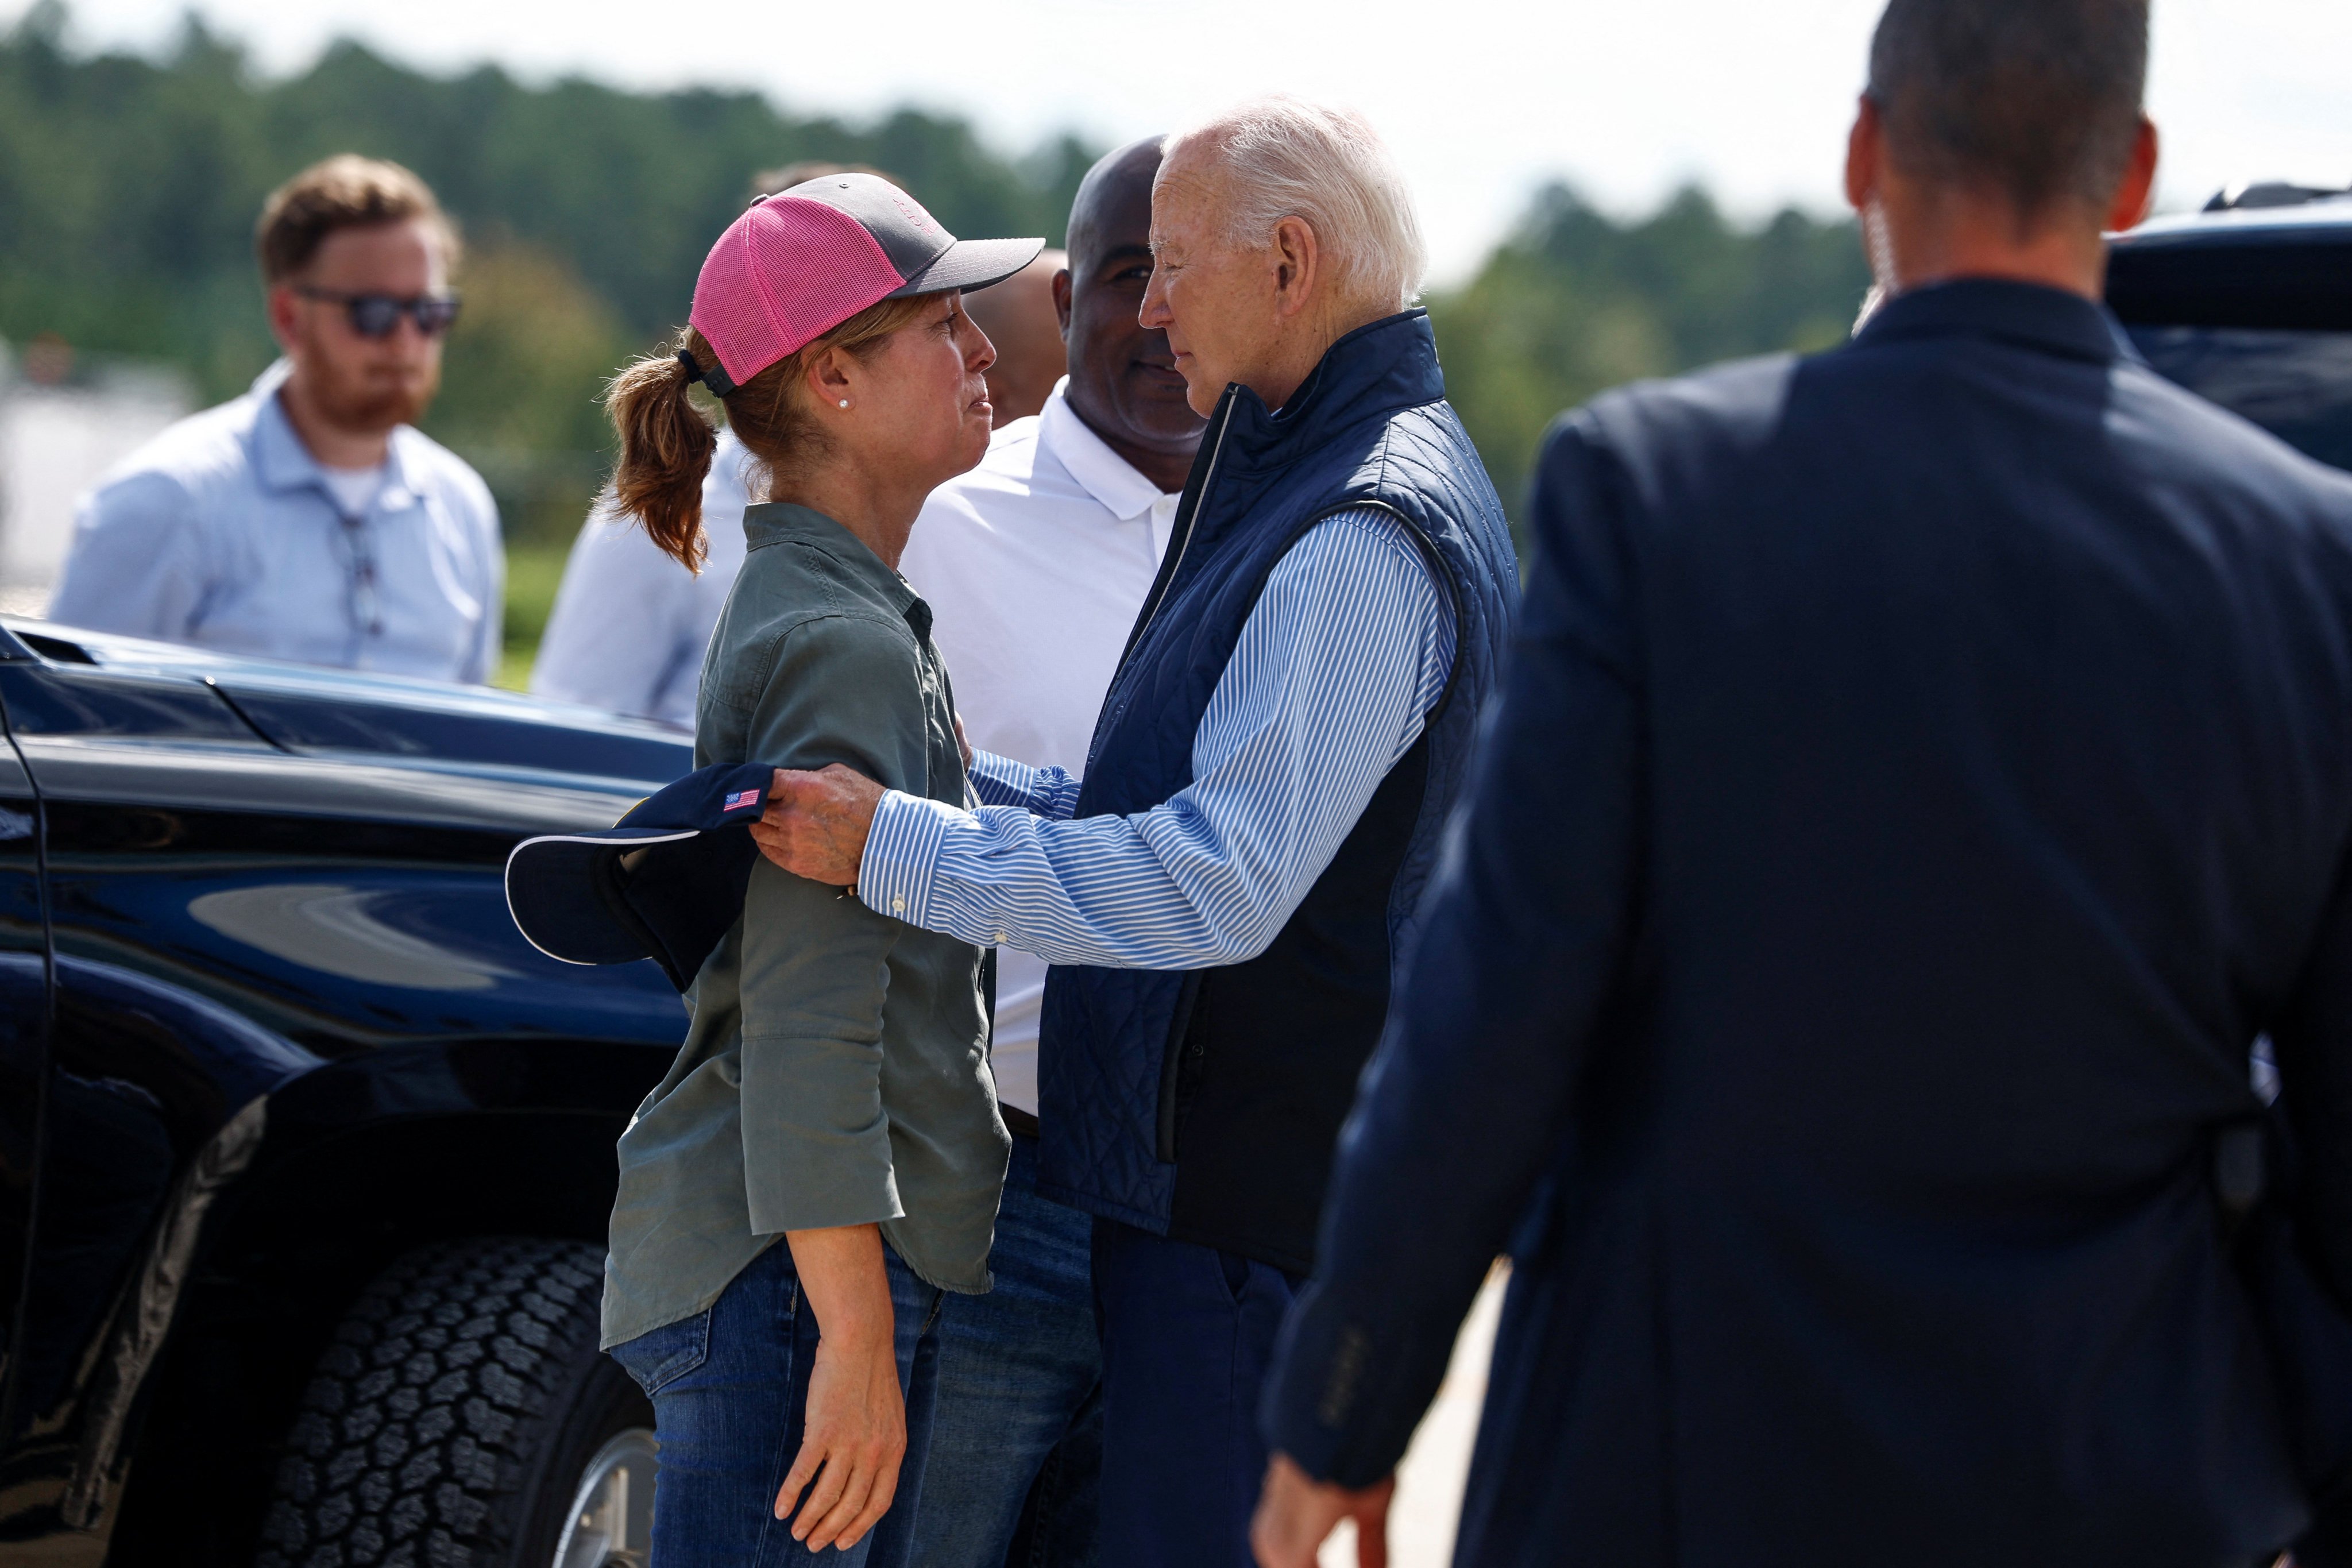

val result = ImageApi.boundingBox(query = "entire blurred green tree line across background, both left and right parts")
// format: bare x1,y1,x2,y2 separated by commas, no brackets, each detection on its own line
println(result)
0,0,1867,658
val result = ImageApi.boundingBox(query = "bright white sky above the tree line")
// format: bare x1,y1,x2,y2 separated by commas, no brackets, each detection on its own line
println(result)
18,0,2352,282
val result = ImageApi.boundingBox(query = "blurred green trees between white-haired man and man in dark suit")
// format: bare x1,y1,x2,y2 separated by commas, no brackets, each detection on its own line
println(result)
1430,186,1870,534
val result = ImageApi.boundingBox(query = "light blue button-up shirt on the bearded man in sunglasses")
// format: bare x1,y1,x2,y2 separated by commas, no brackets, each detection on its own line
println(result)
49,360,505,684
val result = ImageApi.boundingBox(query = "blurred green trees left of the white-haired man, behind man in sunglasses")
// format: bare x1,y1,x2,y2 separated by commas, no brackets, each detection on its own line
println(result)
0,0,1094,538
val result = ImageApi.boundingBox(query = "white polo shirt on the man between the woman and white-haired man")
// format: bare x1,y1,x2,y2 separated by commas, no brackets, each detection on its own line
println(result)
898,379,1176,1114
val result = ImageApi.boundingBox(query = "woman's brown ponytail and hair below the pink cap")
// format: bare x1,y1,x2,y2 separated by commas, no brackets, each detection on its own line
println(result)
604,294,939,571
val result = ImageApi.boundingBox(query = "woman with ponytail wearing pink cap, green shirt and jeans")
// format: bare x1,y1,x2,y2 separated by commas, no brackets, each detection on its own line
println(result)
604,174,1042,1568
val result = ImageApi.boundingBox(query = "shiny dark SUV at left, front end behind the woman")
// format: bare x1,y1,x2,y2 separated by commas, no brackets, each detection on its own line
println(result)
0,621,692,1568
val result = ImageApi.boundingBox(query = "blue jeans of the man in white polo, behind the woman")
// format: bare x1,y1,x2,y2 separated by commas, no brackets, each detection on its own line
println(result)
915,1133,1103,1568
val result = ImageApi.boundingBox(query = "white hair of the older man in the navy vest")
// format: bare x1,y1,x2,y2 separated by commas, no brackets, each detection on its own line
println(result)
1160,94,1430,315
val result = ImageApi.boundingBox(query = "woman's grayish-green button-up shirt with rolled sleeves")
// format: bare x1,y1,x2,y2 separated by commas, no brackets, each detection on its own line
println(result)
604,503,1011,1347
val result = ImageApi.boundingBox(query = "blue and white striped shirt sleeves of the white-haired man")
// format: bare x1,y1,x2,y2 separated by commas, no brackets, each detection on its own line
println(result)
859,508,1454,968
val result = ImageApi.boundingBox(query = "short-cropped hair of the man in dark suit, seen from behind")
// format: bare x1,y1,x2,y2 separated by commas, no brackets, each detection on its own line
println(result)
1870,0,2148,217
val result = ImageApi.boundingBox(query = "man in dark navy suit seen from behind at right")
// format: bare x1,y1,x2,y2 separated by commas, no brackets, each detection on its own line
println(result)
1256,0,2352,1568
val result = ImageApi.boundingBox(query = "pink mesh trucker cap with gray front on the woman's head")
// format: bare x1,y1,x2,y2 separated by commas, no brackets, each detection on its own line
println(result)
687,174,1044,397
